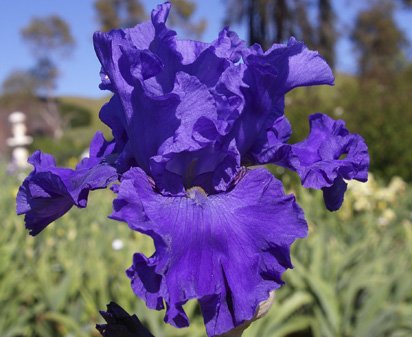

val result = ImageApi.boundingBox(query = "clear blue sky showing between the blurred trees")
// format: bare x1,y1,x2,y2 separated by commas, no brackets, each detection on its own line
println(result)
0,0,412,97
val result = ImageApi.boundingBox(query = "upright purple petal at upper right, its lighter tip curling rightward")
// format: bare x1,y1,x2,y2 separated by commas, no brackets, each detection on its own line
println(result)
217,38,334,155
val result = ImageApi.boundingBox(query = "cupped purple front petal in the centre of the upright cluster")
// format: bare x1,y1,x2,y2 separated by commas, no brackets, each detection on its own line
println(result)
127,68,240,194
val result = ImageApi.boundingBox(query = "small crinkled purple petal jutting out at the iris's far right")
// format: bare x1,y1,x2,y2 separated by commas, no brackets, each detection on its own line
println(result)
292,114,369,211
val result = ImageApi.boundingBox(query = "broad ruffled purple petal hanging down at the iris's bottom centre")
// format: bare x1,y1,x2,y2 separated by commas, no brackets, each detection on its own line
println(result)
111,168,307,336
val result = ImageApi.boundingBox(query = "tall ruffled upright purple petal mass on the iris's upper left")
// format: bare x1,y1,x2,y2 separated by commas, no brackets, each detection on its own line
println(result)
94,9,245,194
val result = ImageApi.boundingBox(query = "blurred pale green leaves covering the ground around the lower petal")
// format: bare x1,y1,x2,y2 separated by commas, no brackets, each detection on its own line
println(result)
0,164,412,337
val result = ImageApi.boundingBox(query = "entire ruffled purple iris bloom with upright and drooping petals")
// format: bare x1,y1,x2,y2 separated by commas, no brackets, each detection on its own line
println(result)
17,2,369,336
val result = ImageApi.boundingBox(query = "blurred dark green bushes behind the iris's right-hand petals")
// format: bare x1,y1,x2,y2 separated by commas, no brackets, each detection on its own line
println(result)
286,66,412,182
